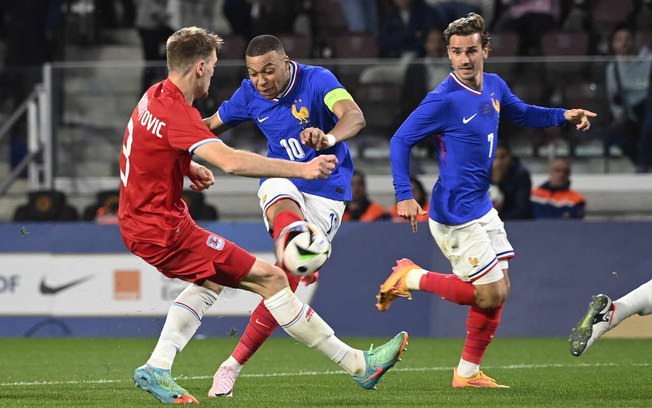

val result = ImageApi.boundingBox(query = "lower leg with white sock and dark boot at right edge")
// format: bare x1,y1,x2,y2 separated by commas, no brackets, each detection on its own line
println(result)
569,280,652,357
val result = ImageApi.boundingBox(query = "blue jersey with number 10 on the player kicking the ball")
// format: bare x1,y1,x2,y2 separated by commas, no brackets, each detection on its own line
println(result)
217,61,353,201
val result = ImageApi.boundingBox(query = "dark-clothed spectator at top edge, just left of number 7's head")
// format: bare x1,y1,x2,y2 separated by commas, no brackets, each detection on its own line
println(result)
378,0,435,58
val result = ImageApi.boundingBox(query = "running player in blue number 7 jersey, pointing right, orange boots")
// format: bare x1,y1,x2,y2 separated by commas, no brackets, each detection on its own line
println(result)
376,13,596,388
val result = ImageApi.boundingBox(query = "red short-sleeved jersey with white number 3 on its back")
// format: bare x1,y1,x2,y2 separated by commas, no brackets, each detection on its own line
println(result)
118,79,220,246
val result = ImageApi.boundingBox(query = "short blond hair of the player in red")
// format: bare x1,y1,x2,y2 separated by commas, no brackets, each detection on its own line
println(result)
165,27,224,72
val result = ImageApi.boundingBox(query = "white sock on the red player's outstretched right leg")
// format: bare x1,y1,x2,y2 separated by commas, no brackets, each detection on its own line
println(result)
265,288,366,375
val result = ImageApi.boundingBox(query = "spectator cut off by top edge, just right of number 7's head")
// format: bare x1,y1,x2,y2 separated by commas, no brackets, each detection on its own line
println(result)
501,0,561,56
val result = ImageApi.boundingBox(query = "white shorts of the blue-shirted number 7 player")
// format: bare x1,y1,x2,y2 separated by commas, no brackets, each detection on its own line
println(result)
429,208,514,285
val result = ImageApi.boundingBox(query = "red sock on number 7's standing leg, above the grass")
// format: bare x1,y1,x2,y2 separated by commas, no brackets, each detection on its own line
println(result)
462,305,503,365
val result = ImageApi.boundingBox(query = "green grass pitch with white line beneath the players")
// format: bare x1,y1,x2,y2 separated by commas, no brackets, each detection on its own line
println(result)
0,337,652,408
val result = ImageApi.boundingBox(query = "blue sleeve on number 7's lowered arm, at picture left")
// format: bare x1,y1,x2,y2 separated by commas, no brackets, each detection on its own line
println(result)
389,93,445,201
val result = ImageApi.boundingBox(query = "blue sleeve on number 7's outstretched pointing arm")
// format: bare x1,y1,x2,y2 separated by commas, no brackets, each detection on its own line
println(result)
500,79,566,128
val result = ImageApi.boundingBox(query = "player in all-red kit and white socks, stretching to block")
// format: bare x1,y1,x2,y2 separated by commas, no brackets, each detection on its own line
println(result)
119,27,407,404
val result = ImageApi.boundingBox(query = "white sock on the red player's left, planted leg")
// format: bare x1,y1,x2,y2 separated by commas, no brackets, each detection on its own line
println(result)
147,283,218,369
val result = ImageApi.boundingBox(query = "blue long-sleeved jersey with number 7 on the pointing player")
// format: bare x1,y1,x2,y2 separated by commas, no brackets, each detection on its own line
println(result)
390,72,565,225
